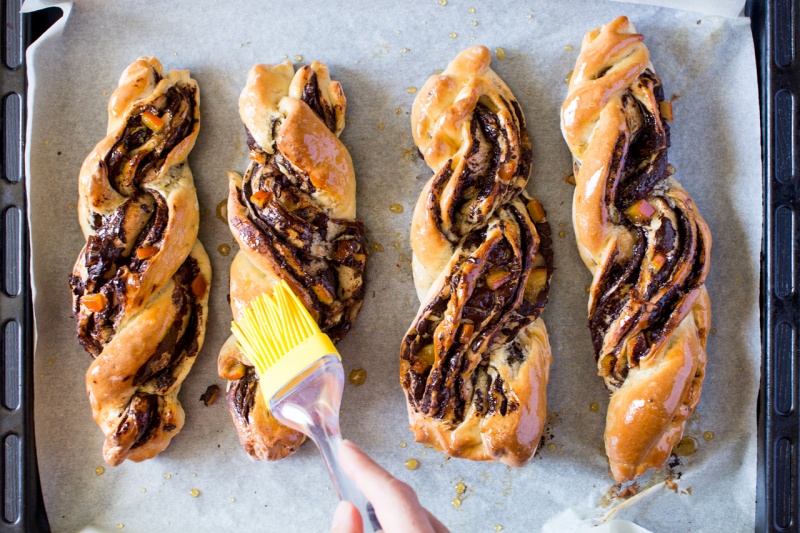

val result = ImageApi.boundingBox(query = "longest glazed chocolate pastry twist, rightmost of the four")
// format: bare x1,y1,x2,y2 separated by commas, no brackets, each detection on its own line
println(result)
561,17,711,481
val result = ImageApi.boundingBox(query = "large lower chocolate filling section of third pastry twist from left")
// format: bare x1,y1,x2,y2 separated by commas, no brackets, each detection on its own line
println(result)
401,204,553,423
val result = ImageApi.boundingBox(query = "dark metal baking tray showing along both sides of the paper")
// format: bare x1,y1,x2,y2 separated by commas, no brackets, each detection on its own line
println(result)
0,0,788,532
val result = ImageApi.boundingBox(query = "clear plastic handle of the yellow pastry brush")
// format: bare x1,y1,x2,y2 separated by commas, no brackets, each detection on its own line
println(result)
269,355,382,533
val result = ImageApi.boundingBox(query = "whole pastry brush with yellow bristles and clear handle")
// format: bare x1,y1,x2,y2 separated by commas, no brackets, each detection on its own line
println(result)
231,280,381,532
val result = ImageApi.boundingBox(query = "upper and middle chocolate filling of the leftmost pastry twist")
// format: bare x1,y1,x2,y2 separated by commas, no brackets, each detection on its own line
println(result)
69,86,196,357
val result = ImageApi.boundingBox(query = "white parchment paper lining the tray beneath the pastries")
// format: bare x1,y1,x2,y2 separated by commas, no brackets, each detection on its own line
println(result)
28,0,762,532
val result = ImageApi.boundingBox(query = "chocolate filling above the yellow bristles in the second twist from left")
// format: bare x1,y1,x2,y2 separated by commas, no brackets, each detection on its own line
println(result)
236,74,367,342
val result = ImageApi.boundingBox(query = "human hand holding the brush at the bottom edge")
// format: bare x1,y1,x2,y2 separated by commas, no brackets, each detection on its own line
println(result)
331,440,449,533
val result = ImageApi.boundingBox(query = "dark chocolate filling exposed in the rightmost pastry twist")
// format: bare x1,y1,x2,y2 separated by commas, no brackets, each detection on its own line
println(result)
589,70,708,390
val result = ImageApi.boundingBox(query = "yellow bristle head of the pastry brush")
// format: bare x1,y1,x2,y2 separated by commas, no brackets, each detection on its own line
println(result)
231,280,341,404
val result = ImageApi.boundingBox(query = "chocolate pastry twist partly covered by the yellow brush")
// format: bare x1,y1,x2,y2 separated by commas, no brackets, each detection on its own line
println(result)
218,61,366,460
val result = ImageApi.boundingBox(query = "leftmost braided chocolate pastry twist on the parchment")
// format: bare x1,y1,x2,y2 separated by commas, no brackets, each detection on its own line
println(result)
70,57,211,466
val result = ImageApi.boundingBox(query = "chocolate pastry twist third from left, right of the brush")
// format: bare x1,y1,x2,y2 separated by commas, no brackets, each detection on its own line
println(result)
400,46,553,466
